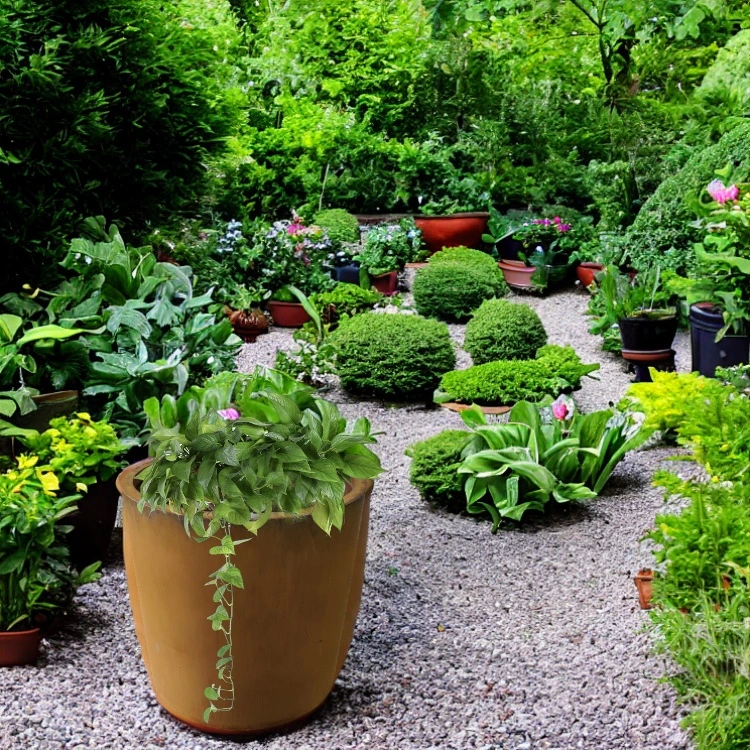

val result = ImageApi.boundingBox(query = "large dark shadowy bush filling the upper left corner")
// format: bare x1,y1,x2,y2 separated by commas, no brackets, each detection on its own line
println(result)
0,0,246,288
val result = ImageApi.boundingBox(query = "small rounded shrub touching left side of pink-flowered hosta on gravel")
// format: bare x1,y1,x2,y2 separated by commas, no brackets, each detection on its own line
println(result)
406,430,471,513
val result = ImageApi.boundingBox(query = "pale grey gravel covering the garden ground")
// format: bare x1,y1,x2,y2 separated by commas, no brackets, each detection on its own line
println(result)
0,291,689,750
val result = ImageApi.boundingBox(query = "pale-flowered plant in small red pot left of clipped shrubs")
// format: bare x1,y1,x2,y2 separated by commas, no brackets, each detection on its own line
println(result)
357,220,421,295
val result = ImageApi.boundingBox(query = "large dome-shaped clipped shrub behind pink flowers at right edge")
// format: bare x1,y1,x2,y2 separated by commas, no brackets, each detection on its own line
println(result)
621,123,750,271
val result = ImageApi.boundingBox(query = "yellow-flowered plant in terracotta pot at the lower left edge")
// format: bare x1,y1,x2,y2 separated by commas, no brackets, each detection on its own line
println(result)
0,456,99,667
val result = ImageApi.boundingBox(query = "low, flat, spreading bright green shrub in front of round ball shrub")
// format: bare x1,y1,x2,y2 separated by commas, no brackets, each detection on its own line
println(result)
435,344,599,406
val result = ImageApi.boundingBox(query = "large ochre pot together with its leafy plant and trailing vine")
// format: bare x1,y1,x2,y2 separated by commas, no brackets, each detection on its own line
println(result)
117,369,380,735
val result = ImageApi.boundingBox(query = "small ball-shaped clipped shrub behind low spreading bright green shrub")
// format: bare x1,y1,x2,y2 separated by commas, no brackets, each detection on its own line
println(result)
464,299,547,365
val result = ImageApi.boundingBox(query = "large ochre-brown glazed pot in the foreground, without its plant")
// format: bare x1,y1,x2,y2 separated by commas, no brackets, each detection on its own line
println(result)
117,461,373,735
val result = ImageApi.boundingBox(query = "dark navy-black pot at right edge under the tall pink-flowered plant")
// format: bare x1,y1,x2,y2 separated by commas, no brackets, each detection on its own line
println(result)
690,302,750,378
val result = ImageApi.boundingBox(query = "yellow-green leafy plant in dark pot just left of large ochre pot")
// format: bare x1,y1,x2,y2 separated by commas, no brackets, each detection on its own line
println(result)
17,412,134,570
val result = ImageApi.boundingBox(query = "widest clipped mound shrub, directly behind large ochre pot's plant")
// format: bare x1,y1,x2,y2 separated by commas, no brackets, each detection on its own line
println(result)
331,312,456,401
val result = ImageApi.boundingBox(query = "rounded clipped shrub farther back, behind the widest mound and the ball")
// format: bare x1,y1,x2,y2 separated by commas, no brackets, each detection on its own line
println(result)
412,262,507,322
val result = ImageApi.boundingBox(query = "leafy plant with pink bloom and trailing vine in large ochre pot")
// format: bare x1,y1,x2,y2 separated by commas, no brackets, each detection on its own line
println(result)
139,368,381,721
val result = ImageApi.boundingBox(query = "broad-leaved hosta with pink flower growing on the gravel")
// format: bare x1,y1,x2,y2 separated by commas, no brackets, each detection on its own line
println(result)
458,397,649,532
